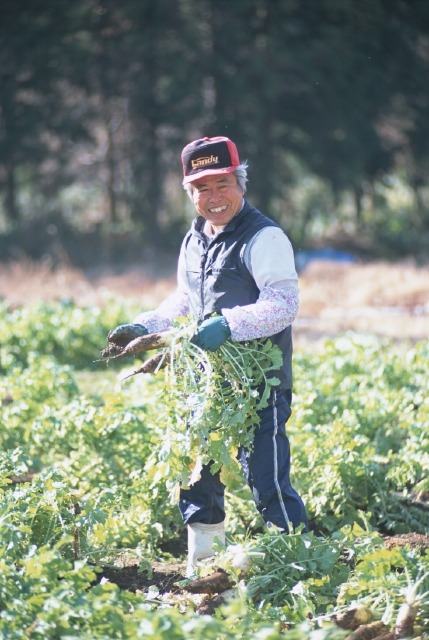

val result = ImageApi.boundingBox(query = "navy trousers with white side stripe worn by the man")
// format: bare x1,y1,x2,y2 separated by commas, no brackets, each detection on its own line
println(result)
179,391,307,532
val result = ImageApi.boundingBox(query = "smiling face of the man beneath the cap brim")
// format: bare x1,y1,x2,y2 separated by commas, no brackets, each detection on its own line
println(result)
192,173,244,229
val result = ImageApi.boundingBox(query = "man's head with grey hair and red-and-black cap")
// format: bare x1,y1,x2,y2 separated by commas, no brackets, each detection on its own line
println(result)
182,137,247,228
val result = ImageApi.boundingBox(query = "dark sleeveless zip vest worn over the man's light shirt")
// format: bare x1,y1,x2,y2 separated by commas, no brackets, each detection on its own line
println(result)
183,200,292,389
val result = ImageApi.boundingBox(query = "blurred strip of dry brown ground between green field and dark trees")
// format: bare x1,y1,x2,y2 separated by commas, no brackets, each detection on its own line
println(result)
0,260,429,348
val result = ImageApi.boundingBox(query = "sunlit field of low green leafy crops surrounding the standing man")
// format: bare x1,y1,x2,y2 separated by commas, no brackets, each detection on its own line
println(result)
0,300,429,640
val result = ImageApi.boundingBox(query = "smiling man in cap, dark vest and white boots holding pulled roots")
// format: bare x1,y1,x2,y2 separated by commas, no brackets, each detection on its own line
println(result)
108,137,307,575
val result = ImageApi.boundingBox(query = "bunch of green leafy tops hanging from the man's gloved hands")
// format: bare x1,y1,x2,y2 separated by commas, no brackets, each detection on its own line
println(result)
139,318,282,501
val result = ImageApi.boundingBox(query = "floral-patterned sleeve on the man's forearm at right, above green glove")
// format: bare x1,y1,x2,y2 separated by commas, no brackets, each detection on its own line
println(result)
222,286,299,342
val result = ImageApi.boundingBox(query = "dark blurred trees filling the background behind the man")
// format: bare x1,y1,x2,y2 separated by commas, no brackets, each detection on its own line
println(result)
0,0,429,267
